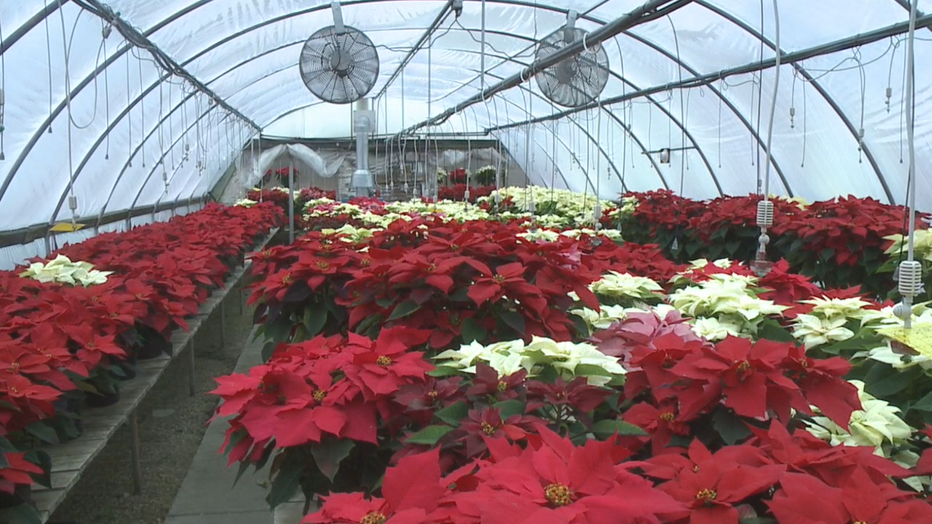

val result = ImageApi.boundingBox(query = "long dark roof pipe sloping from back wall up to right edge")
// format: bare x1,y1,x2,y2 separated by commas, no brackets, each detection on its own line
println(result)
486,15,932,131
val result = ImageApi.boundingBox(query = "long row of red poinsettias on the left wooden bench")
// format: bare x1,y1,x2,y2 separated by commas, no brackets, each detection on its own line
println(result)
0,205,281,492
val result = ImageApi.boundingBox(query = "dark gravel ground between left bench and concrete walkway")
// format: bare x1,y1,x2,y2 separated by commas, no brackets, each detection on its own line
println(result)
49,289,252,524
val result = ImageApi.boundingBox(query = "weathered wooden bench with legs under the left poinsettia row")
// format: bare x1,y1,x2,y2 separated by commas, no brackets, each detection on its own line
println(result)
33,228,278,522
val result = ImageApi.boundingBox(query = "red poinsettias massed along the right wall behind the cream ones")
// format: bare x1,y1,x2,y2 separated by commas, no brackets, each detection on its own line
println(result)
619,191,928,295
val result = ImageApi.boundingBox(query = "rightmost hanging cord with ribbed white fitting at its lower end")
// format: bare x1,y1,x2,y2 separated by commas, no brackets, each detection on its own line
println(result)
893,0,922,329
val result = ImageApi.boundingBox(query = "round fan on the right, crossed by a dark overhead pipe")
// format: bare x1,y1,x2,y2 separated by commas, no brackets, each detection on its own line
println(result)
534,28,609,107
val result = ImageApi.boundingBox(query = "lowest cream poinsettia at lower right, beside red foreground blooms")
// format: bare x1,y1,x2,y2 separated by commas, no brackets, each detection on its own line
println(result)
805,380,913,458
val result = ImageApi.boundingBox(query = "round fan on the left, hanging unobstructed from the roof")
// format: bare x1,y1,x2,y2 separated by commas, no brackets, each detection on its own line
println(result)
299,26,379,104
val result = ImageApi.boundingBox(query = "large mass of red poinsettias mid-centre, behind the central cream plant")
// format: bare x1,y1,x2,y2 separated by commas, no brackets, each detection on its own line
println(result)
250,217,677,348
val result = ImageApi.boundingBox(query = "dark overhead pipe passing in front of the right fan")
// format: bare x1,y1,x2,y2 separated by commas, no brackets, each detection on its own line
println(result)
396,0,692,136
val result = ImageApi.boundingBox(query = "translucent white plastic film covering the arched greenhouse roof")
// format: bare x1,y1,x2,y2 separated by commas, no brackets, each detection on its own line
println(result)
0,0,932,234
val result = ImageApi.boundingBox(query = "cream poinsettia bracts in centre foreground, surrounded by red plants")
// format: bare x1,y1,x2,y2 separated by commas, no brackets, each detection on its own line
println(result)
435,337,625,385
